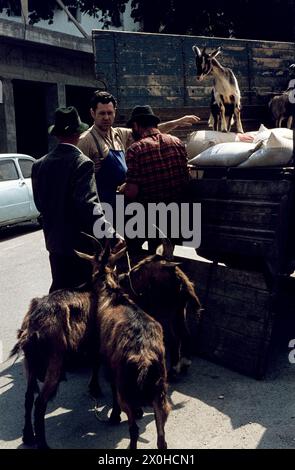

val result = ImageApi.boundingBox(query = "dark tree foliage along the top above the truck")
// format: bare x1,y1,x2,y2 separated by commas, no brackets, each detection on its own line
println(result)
0,0,295,41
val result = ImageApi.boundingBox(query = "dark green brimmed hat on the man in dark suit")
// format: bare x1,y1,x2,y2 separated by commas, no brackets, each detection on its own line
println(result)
48,106,89,136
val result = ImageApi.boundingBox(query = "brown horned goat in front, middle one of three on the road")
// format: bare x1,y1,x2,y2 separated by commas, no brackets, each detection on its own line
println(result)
81,241,170,449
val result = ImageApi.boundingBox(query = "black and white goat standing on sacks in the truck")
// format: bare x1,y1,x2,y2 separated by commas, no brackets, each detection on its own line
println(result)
193,46,244,133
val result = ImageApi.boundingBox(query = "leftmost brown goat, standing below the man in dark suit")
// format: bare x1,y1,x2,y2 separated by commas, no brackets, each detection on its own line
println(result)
11,264,99,449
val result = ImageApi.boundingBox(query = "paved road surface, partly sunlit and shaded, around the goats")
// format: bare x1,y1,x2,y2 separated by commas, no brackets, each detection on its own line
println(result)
0,229,295,449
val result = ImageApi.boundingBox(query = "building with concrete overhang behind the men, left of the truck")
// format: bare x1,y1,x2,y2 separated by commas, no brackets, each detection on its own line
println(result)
0,20,99,157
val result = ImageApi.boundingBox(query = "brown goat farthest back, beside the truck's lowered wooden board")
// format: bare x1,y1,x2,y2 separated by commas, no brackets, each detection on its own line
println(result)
120,239,201,379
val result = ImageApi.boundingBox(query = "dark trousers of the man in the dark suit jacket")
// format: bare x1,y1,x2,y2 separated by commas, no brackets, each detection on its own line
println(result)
49,253,92,292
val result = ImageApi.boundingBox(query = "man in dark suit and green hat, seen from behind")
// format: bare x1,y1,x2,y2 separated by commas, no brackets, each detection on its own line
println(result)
32,106,125,292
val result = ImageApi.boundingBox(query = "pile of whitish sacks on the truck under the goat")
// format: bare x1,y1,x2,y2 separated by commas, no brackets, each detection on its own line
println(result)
187,125,294,168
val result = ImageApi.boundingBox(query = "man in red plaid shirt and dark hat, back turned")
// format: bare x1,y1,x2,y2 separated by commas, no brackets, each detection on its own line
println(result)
122,106,189,253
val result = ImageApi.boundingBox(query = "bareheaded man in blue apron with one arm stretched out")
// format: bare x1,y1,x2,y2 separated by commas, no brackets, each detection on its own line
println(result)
78,91,199,204
